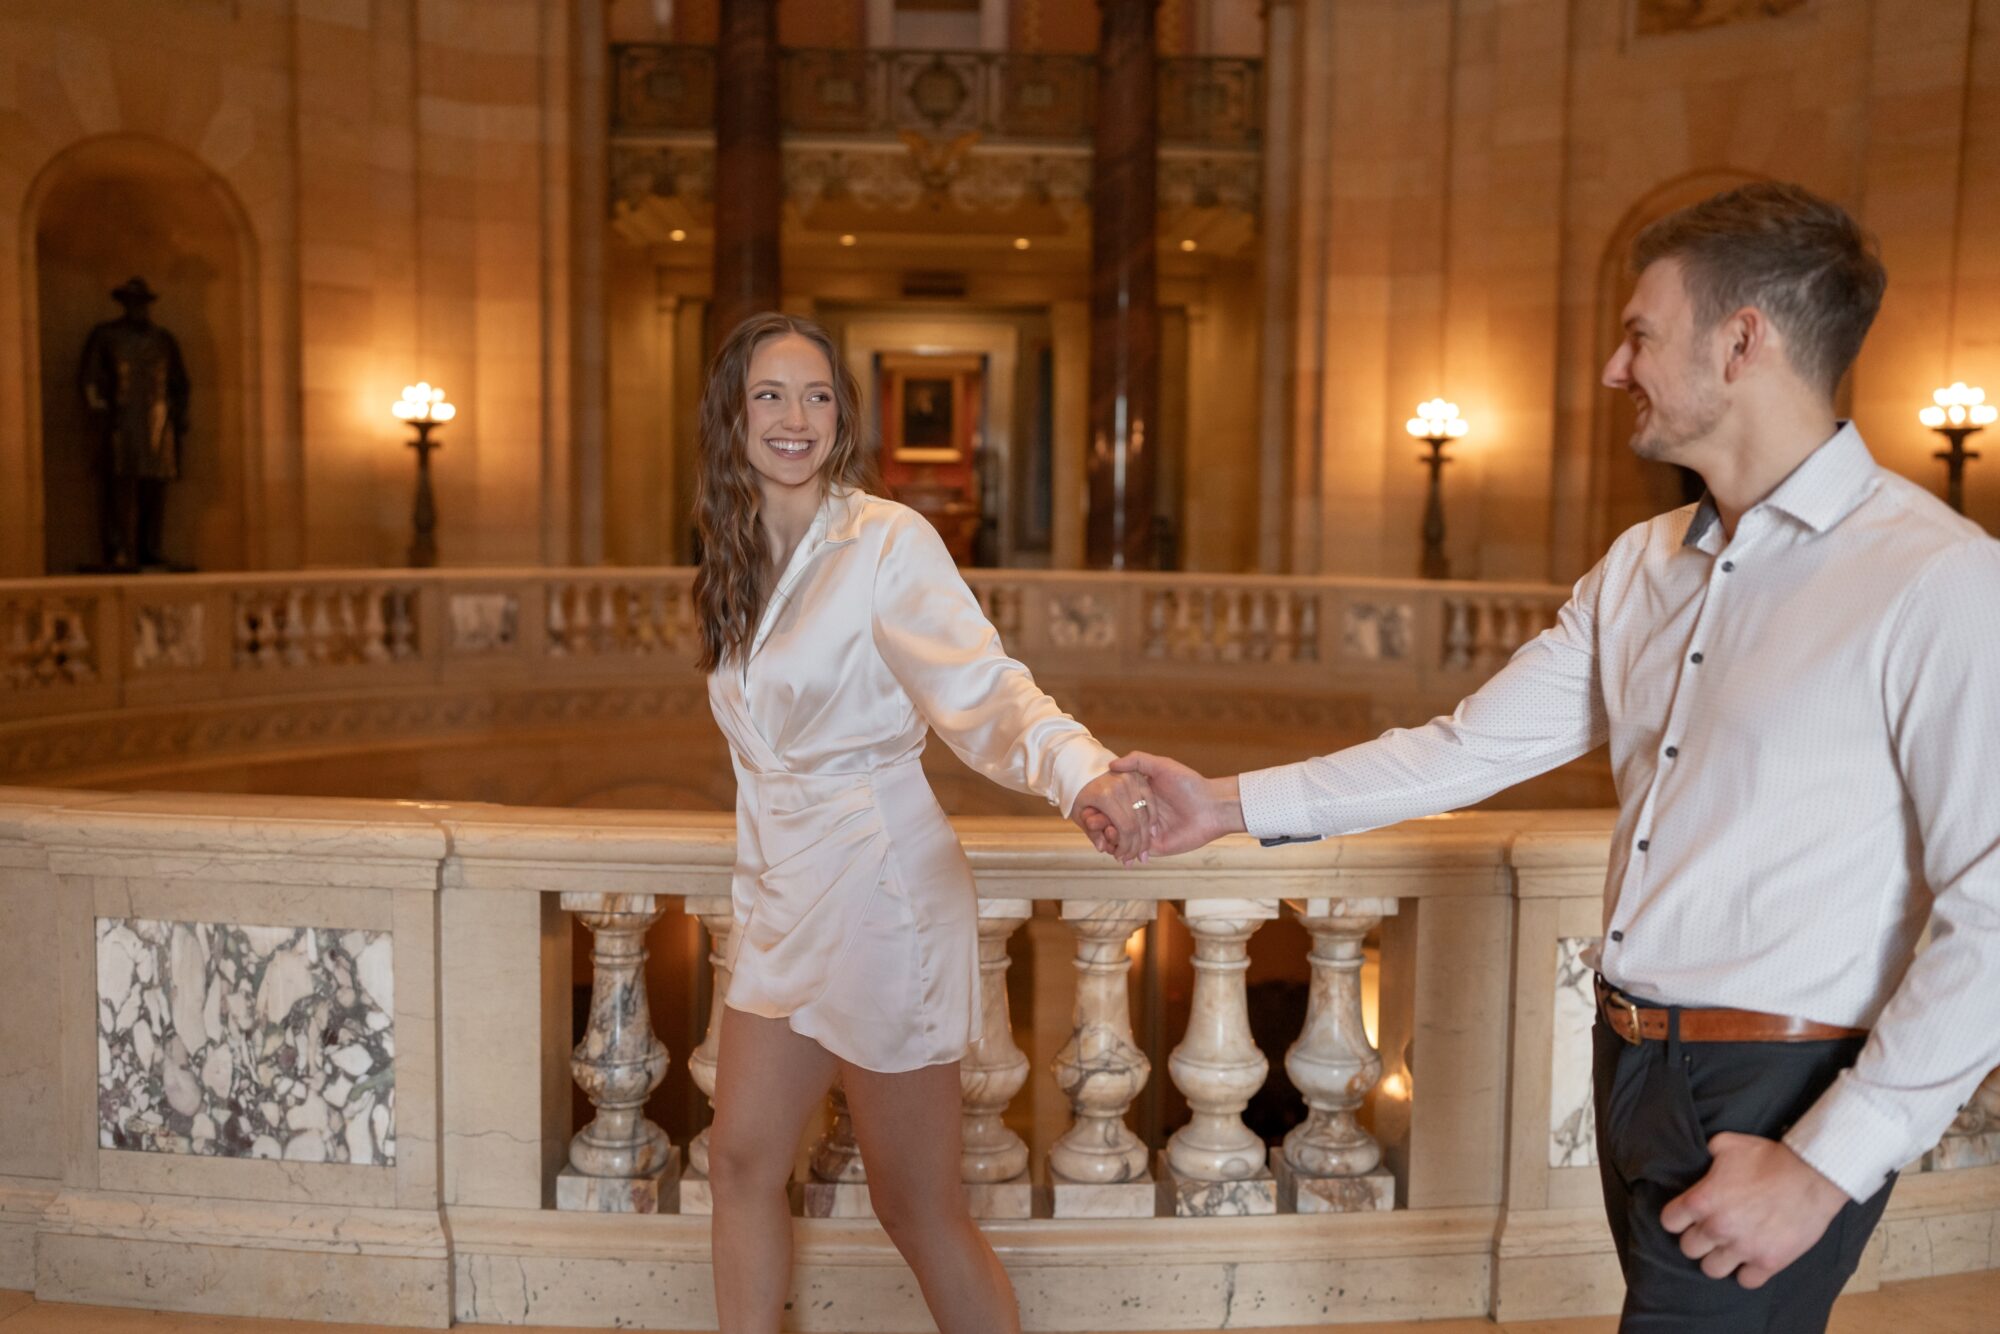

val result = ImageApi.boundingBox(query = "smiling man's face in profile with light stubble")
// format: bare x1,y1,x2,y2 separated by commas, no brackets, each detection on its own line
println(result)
1604,258,1724,462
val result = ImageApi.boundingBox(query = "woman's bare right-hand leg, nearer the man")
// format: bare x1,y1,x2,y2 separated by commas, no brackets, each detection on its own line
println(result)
840,1060,1020,1334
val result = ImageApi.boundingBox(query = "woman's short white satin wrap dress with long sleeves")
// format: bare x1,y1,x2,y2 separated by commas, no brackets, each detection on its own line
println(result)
708,490,1112,1072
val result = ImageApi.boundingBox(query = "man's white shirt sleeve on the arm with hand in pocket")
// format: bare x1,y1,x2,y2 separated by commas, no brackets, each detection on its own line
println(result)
1784,538,2000,1200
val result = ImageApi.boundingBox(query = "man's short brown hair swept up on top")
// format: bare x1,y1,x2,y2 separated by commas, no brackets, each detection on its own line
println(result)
1632,182,1888,398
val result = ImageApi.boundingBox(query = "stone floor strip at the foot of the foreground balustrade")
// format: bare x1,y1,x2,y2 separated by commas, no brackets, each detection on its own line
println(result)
0,1270,2000,1334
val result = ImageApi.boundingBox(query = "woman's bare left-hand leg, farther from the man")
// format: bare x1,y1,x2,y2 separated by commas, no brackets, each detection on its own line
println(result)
708,1008,840,1334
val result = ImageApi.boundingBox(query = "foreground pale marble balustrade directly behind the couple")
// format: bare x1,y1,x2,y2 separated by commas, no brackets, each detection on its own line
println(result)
0,788,2000,1332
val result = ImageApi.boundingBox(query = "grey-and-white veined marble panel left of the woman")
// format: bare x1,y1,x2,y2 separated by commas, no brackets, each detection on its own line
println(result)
96,918,396,1166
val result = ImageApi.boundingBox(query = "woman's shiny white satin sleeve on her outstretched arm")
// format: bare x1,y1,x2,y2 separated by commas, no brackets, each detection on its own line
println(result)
872,512,1116,814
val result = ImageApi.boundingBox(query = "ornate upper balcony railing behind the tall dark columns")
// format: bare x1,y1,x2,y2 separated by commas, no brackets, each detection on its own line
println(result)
612,42,1264,148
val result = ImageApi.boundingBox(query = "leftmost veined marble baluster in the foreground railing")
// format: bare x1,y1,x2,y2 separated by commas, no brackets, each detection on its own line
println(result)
556,894,680,1214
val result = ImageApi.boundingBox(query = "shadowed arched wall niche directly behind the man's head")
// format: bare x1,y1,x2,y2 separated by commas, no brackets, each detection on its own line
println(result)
1588,170,1762,552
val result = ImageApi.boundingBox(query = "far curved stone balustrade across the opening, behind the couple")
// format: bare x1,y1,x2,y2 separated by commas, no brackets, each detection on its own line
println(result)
0,568,1568,720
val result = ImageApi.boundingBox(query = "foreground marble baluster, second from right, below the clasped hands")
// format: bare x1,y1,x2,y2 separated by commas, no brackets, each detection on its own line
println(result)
1160,898,1278,1218
